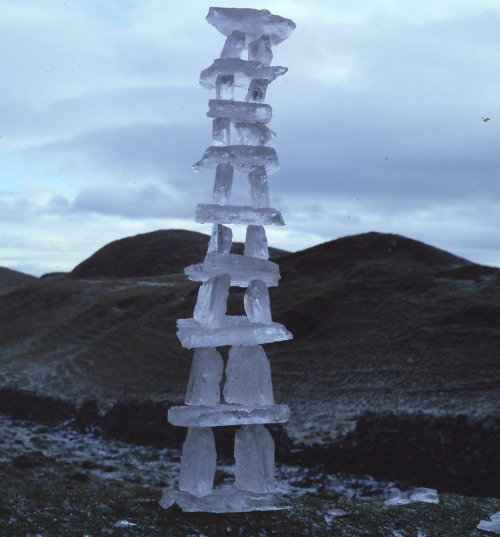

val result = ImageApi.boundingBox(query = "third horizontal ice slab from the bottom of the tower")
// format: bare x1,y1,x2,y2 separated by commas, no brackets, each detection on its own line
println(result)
177,315,293,349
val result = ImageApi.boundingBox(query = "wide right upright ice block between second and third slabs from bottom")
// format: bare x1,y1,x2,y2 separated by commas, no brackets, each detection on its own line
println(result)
224,345,274,406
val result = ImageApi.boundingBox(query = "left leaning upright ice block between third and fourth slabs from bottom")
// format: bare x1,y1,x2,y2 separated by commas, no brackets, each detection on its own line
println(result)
193,274,231,328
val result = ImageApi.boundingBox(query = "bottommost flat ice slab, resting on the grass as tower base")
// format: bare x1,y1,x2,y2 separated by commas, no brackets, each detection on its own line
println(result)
159,488,291,513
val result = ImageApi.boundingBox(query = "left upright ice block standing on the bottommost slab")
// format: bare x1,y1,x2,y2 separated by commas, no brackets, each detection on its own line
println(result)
179,427,217,498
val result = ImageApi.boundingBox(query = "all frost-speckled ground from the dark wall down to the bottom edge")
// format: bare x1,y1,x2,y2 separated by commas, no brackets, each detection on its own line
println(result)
0,418,500,537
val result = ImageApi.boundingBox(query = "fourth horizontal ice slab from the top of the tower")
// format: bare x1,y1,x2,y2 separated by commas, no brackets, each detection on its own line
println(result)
193,145,279,175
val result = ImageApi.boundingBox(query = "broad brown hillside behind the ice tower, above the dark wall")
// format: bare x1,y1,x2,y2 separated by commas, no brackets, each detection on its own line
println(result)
0,232,500,441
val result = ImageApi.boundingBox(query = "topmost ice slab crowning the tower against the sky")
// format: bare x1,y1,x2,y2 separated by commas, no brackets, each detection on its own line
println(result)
207,7,295,45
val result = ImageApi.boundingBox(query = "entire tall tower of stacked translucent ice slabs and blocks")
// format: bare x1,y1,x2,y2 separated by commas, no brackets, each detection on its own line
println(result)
161,8,295,512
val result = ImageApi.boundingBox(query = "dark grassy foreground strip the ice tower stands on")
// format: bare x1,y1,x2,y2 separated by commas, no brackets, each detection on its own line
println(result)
0,482,500,537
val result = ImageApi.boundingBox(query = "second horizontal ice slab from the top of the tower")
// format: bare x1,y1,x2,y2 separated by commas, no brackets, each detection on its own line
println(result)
200,58,288,90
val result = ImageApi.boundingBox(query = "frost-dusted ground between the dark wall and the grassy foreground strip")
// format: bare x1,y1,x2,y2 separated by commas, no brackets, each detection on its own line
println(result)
0,415,401,498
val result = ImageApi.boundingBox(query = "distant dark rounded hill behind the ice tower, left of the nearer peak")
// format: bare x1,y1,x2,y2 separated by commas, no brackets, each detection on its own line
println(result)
70,229,287,278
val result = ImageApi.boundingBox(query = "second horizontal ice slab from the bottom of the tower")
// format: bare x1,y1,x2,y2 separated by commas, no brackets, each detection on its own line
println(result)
168,405,290,428
